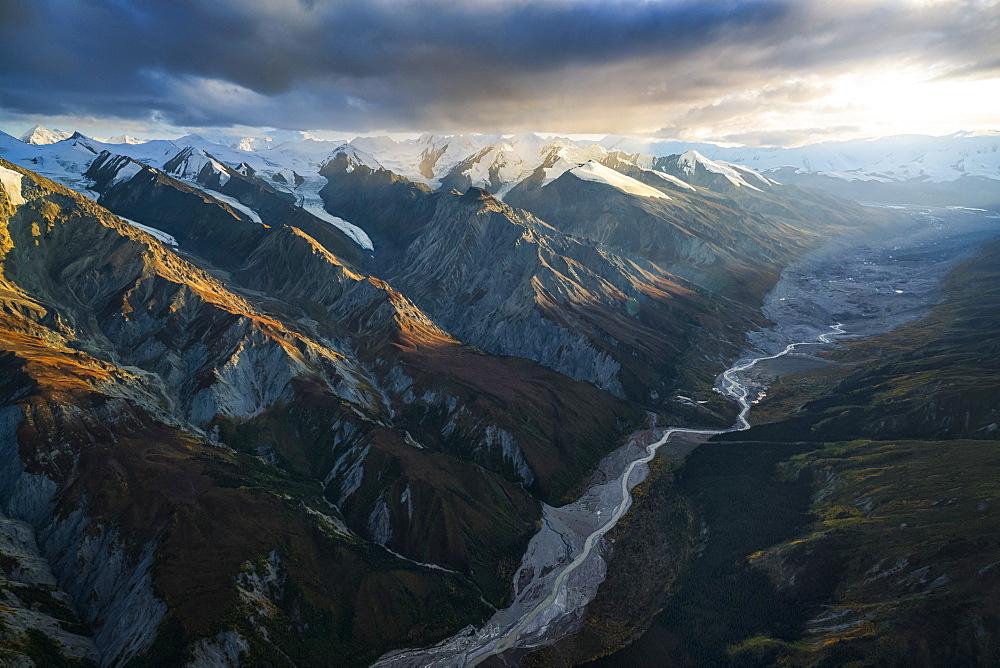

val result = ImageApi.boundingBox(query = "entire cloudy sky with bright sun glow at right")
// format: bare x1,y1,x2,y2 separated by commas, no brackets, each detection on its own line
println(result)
0,0,1000,145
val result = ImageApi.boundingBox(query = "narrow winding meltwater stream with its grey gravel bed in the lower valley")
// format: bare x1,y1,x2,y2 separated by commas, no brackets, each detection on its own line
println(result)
373,323,845,668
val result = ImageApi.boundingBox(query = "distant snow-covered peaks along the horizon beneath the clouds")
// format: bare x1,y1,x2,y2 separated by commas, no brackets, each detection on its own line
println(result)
21,126,1000,210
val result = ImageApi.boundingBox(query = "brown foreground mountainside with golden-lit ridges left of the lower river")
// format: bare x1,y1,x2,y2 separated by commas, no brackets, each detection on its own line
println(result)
2,163,629,665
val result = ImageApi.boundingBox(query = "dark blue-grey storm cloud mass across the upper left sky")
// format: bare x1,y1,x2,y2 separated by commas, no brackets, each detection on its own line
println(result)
0,0,784,123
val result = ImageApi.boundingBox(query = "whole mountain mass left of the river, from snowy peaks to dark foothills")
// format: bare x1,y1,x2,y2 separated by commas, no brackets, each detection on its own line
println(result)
0,122,997,666
